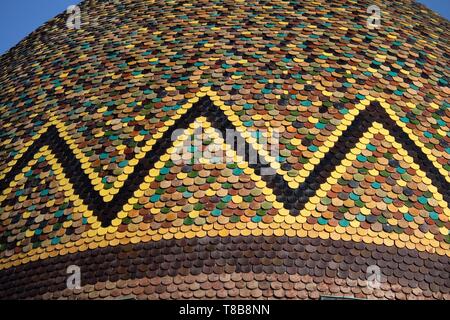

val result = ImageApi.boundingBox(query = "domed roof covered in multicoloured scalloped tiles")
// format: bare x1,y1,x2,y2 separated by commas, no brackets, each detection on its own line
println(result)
0,0,450,299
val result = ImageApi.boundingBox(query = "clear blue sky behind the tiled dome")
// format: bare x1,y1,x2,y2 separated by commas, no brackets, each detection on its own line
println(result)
0,0,450,55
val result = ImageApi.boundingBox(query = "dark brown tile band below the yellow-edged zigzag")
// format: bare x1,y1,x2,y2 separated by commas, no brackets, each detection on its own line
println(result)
0,236,450,299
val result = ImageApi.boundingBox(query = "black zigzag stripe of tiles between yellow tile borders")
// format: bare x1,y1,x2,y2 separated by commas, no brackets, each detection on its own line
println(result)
0,97,450,226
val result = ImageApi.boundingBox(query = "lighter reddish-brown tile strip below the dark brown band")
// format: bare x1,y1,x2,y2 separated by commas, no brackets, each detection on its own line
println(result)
35,272,450,300
